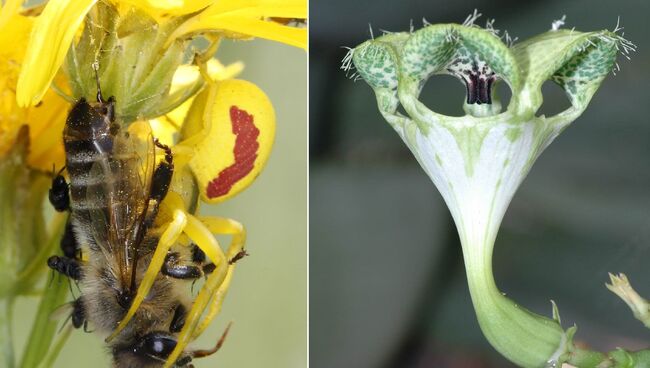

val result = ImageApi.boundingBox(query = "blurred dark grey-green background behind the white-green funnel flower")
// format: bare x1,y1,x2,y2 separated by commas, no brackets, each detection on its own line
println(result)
309,0,650,368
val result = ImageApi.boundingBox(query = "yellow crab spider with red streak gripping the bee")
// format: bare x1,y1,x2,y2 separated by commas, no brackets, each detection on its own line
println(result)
106,73,275,367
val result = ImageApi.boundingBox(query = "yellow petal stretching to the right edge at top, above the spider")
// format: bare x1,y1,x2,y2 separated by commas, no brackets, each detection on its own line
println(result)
171,0,307,49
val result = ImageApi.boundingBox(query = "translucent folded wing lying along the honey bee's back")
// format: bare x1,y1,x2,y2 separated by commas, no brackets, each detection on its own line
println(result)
87,123,155,282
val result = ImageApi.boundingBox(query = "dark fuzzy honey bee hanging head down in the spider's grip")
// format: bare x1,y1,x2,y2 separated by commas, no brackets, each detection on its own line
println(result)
48,84,240,368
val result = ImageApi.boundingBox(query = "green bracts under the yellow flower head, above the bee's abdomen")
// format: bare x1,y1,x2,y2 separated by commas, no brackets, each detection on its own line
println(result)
65,3,203,125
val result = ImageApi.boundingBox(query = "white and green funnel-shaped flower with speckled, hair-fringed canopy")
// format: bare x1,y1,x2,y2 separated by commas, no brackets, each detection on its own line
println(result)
343,12,634,367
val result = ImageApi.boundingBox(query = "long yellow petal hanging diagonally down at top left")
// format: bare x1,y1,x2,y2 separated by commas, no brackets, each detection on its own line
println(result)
16,0,97,106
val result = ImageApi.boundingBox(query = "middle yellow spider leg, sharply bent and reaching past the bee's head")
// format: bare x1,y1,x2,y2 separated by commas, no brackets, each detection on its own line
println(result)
165,214,228,368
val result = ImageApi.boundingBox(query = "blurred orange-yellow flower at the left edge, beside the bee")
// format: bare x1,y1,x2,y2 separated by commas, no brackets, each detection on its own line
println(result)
0,9,68,171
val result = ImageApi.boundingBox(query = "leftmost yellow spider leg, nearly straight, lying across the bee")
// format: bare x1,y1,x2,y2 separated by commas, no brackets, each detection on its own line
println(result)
106,209,188,342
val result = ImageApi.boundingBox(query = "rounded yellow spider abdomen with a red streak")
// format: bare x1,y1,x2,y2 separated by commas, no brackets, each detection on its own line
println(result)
179,79,275,203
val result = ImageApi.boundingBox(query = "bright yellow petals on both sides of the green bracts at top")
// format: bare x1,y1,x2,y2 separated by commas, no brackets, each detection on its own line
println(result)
17,0,307,106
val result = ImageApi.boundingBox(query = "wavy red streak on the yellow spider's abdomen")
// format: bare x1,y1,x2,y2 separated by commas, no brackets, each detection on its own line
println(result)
207,106,260,198
